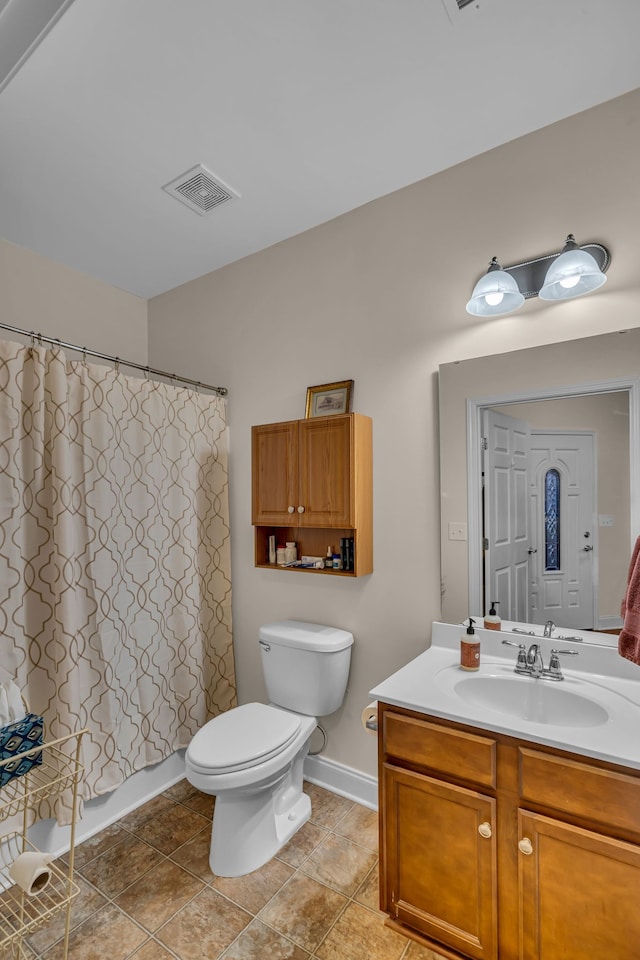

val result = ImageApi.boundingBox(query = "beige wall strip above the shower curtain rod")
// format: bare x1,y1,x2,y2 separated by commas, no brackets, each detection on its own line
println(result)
0,240,148,364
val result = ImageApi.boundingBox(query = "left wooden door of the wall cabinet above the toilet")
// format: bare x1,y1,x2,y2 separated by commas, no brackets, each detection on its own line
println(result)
251,420,298,527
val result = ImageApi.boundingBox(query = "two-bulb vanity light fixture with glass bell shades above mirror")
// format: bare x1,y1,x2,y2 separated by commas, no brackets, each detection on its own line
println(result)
467,233,611,317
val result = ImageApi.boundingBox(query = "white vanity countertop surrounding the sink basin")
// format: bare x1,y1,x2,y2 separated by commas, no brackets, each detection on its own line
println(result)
370,623,640,769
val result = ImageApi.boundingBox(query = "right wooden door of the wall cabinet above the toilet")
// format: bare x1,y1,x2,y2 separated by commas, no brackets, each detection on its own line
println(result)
296,416,353,527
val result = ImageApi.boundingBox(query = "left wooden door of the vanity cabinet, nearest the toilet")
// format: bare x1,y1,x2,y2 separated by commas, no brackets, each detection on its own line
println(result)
381,763,498,960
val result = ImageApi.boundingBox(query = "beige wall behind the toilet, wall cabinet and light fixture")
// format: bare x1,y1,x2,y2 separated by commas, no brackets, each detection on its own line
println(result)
149,91,640,773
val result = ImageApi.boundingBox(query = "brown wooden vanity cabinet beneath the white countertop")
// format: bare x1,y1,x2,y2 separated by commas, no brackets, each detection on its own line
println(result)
379,703,640,960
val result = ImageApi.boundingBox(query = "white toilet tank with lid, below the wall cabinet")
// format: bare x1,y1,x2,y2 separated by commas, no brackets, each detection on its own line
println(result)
258,620,353,717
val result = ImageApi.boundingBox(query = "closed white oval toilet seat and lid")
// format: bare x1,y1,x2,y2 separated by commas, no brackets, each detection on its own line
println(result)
187,703,302,774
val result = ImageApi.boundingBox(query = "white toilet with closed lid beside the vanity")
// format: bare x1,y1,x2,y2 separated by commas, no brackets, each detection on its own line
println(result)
186,620,353,877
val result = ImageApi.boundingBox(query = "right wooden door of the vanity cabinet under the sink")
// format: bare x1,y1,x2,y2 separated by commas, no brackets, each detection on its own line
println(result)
519,811,640,960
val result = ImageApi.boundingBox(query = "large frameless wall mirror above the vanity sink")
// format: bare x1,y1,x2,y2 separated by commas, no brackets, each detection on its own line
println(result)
439,329,640,630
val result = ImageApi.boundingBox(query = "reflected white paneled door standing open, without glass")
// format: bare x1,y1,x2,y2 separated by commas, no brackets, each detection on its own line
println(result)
483,410,530,622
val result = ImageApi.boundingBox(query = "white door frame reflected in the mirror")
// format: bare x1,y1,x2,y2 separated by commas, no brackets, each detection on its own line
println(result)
466,377,640,616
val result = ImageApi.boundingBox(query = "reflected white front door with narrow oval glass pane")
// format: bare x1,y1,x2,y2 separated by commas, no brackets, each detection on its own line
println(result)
528,430,597,630
